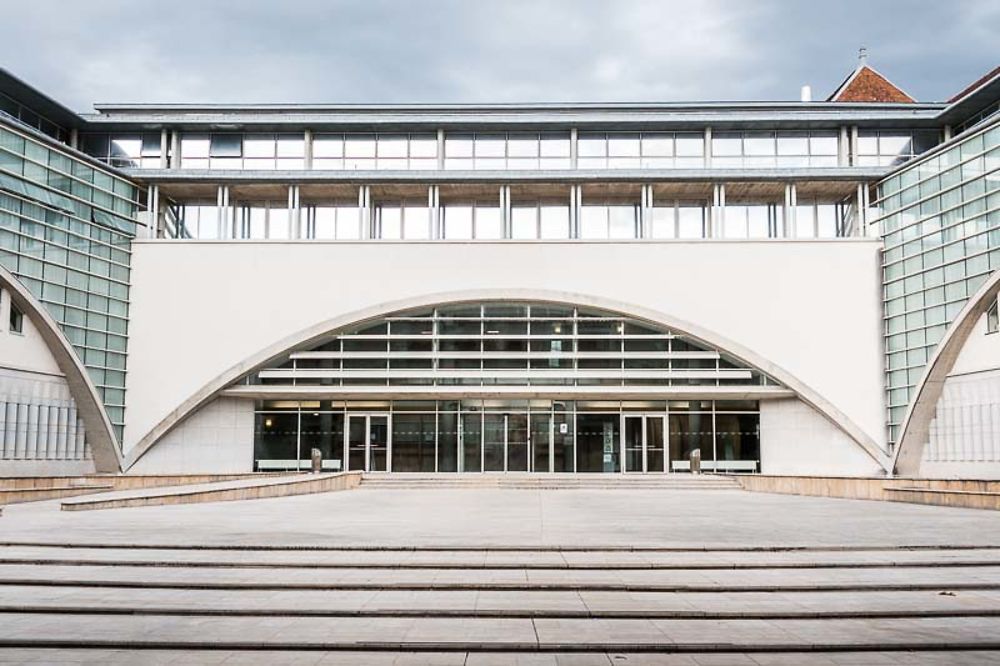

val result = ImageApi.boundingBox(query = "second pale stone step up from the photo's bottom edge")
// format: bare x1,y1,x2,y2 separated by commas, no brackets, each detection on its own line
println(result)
0,613,1000,653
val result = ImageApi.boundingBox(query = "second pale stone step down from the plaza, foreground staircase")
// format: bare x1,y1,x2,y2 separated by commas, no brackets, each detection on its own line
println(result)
0,564,1000,592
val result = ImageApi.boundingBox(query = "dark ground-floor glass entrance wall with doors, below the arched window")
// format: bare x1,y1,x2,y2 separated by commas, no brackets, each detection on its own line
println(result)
254,399,760,473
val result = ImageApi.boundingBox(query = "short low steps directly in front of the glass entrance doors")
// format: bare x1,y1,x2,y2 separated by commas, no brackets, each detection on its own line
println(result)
361,472,740,490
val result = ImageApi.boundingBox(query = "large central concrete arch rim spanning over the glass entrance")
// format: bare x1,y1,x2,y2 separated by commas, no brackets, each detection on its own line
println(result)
125,289,890,470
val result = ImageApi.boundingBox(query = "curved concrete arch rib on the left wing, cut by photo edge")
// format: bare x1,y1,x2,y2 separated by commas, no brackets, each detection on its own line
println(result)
0,266,122,474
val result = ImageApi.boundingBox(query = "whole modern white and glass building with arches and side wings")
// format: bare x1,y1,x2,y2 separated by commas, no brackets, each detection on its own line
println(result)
0,55,1000,476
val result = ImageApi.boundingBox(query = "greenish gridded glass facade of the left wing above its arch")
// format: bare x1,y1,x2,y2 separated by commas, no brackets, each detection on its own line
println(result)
0,119,141,441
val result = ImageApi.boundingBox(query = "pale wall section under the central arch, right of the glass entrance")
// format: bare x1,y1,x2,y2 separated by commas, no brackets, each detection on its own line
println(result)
760,398,880,476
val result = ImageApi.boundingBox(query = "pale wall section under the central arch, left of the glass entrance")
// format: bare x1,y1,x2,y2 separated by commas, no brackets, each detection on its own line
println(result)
128,398,254,474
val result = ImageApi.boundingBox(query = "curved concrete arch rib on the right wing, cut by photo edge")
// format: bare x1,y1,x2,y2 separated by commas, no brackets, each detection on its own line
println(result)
892,271,1000,476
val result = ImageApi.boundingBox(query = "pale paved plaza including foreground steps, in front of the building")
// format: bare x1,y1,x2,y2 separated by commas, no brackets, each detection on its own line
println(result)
0,484,1000,665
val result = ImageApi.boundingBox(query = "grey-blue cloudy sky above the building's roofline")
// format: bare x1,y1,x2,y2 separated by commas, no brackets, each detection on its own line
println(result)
0,0,1000,111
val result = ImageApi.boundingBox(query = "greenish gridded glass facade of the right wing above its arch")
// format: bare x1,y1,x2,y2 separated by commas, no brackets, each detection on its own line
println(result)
876,116,1000,442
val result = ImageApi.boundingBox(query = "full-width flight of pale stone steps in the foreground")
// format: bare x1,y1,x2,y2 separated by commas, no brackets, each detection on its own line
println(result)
0,540,1000,664
